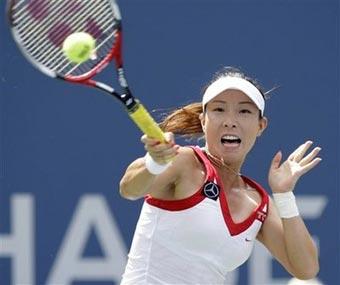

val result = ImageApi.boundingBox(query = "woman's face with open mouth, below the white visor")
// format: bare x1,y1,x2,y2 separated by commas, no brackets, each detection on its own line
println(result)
201,89,267,163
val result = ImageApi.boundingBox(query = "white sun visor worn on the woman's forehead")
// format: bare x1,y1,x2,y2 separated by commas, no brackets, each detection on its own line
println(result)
202,76,265,116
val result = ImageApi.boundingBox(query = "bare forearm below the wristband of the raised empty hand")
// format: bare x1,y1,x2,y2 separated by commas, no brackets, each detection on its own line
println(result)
282,216,319,279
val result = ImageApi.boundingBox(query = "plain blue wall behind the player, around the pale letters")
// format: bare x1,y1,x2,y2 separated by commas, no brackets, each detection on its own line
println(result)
0,0,340,285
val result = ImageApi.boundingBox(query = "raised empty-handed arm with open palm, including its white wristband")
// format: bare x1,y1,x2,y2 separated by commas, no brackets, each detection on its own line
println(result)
258,141,321,279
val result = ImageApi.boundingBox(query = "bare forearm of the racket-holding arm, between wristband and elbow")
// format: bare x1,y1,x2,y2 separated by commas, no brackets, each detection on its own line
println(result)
119,157,156,200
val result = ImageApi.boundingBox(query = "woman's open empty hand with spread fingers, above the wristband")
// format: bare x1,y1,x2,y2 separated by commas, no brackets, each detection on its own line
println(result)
268,141,321,193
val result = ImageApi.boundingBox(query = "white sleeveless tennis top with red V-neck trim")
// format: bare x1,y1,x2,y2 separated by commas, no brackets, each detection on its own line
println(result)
121,147,268,285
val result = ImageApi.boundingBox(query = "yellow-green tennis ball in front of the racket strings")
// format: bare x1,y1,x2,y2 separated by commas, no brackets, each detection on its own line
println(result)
63,32,96,63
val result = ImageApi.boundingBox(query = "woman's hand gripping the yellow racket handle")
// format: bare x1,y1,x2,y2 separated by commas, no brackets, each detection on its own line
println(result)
141,132,179,164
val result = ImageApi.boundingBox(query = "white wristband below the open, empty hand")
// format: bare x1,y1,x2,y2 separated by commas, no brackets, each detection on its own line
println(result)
273,191,299,219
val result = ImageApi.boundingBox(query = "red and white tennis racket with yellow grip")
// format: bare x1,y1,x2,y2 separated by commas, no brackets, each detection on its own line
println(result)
7,0,165,141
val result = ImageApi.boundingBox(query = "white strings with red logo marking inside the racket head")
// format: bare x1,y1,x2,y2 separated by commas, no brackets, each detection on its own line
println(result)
11,0,120,76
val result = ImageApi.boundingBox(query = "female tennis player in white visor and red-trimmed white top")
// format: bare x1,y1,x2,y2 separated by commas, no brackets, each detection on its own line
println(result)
120,69,321,285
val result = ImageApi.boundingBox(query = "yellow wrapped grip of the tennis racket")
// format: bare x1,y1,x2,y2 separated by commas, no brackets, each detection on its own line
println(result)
129,103,165,142
